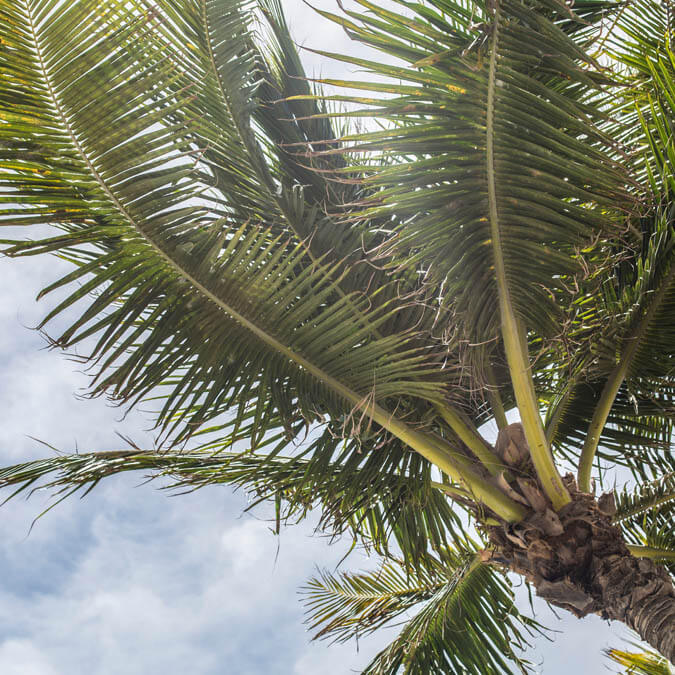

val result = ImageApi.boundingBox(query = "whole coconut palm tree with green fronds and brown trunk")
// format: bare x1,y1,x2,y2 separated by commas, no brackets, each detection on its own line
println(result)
0,0,675,673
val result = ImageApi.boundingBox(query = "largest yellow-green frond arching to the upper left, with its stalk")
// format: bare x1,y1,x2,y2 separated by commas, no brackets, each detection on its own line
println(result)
2,0,532,517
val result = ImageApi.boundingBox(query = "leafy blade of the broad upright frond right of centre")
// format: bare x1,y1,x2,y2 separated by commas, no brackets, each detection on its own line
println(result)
308,2,627,339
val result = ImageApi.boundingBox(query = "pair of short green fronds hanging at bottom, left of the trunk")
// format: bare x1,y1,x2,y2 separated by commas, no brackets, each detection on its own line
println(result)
304,551,541,674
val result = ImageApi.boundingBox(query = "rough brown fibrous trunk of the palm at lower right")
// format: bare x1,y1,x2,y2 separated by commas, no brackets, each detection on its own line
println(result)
485,452,675,662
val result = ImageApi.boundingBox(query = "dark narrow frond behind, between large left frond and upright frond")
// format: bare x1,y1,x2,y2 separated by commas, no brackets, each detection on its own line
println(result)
254,0,440,363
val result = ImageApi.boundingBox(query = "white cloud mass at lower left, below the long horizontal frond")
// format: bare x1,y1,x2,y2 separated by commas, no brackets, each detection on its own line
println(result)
0,472,388,675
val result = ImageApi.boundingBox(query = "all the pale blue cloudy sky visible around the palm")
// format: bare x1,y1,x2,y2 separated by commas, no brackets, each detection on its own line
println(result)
0,0,644,675
